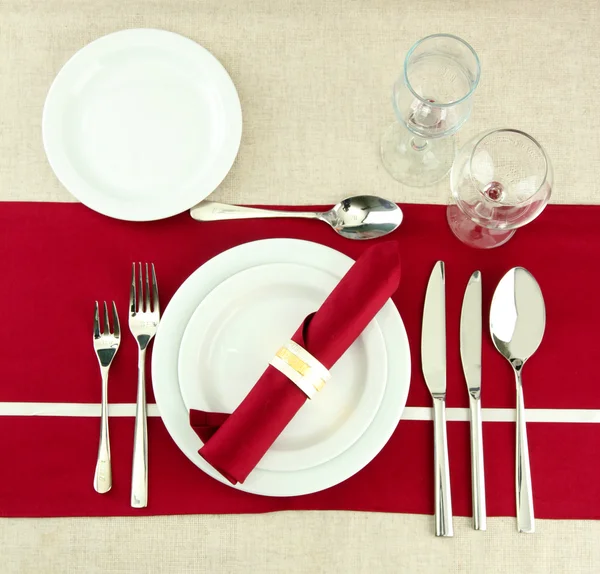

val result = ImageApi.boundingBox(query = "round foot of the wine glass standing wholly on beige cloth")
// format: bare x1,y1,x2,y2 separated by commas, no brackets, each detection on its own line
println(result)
381,122,455,187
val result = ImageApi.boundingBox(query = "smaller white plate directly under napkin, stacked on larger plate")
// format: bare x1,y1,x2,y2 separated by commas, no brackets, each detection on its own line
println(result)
179,263,387,471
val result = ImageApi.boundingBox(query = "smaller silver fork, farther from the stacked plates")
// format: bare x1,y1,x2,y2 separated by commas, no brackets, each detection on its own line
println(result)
94,301,121,494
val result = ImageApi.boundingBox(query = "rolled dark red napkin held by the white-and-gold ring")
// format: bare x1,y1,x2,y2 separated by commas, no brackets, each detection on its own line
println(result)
190,241,400,484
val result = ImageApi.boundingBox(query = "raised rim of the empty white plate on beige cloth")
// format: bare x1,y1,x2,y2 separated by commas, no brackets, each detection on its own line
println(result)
42,28,242,221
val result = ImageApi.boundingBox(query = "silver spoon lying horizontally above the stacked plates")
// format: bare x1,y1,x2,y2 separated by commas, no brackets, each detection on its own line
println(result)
190,195,402,239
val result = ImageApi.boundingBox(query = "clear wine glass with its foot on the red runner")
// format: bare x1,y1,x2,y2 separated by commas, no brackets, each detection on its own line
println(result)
447,129,554,249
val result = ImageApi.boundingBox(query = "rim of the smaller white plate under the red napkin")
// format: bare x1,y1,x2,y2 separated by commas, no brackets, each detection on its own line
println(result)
178,263,387,472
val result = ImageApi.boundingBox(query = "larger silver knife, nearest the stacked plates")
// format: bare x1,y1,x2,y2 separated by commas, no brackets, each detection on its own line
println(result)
421,261,453,536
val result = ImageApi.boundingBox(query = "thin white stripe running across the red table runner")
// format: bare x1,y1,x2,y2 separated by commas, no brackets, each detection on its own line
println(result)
0,403,600,423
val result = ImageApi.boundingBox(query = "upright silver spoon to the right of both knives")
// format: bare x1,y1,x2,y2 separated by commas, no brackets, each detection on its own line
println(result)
490,267,546,532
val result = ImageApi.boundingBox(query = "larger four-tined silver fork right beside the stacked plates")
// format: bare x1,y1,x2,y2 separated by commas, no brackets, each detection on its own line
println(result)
129,263,160,508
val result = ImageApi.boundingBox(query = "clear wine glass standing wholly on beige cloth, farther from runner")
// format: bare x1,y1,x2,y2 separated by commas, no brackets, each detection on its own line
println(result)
381,34,481,187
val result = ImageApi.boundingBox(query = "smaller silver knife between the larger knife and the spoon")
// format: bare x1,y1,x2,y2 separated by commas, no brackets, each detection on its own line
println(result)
460,271,486,530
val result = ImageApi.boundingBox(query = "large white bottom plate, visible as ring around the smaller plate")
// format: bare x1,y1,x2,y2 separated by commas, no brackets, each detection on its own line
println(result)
152,239,410,496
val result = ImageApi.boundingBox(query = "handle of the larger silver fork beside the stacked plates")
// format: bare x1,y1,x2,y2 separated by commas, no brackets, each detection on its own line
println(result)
131,348,148,508
